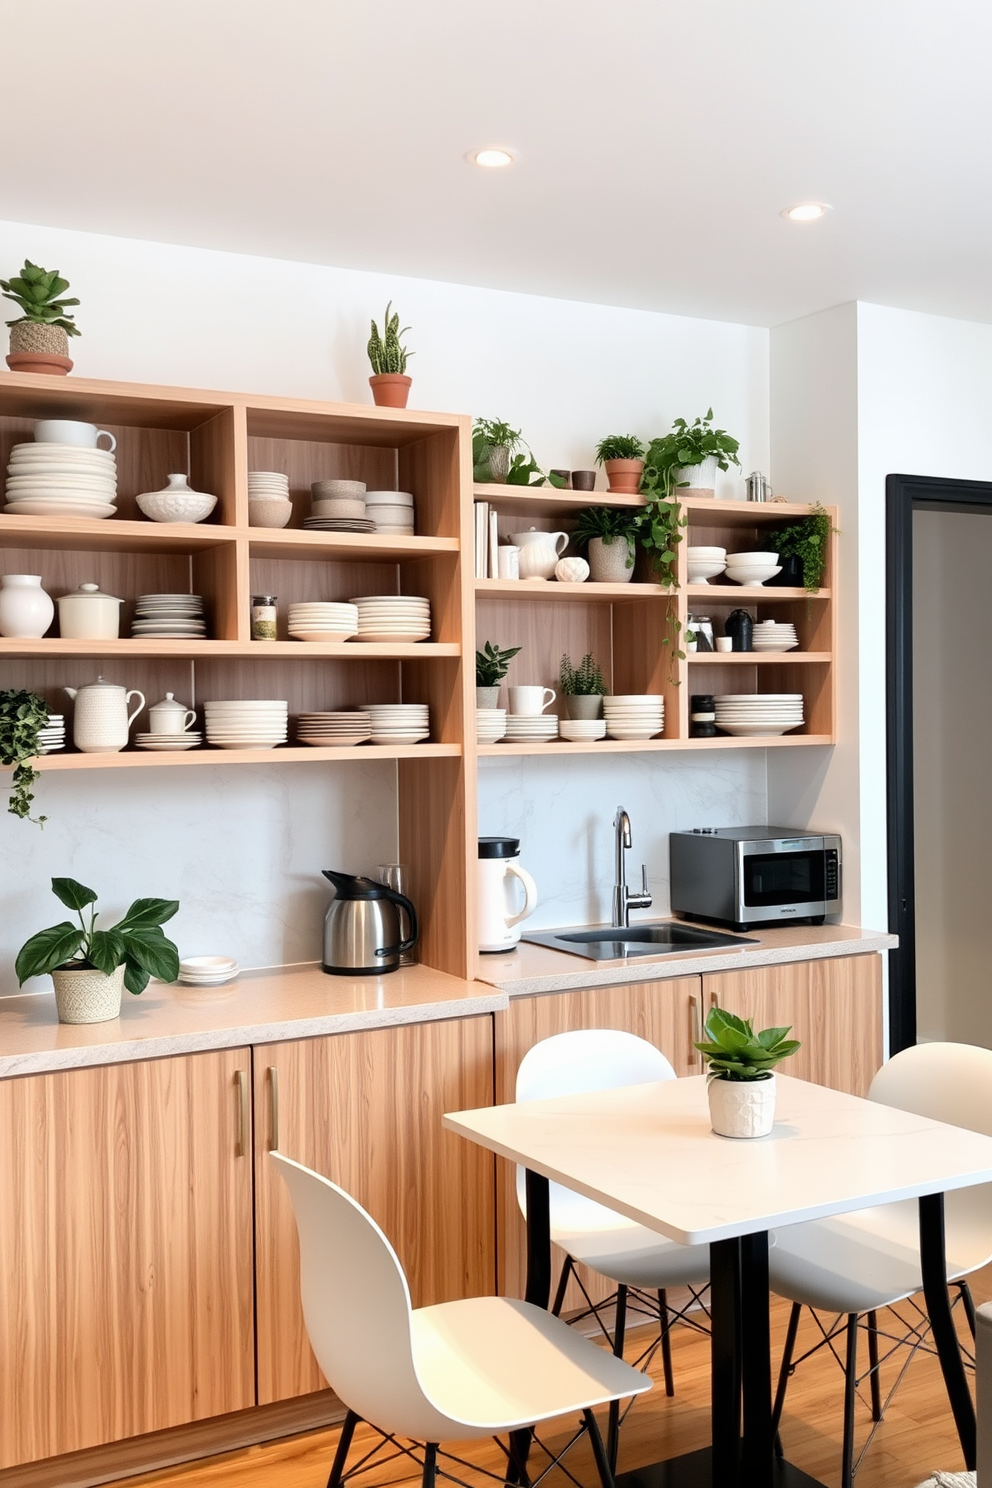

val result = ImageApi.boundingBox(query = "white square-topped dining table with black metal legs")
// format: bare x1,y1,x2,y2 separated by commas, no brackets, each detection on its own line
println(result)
443,1074,992,1488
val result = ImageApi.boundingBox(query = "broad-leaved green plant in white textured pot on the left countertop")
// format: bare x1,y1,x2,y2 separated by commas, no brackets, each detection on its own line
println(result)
15,878,178,1024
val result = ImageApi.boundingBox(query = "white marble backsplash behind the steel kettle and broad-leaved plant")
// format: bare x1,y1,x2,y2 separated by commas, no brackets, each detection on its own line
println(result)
0,760,397,997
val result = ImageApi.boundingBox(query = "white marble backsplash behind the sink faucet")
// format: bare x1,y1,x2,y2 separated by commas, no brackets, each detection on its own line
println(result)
479,750,767,929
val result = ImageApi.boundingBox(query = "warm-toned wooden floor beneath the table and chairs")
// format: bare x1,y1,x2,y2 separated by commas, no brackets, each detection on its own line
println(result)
114,1268,992,1488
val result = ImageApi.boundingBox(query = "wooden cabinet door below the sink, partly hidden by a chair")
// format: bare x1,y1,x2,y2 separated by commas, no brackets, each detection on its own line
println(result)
495,976,700,1309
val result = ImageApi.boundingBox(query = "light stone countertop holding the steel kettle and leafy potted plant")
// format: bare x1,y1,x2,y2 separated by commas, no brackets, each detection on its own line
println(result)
0,966,509,1079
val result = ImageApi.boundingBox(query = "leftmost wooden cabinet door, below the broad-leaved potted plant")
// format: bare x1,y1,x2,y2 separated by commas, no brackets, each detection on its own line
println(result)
0,1049,254,1467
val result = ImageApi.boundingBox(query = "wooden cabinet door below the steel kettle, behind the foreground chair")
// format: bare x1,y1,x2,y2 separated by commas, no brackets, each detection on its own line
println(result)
254,1015,495,1405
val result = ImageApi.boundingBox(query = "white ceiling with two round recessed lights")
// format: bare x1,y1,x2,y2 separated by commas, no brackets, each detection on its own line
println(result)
0,0,992,335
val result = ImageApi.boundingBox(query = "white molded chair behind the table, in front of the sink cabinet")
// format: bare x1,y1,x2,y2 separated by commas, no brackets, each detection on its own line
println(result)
516,1028,709,1467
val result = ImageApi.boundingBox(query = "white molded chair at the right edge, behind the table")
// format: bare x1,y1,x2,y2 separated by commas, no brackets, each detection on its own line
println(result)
769,1043,992,1488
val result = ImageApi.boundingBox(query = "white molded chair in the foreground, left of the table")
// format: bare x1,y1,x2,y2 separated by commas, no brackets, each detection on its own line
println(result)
269,1152,651,1488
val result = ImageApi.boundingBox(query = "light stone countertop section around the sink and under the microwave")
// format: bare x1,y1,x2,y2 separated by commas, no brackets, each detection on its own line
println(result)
479,926,898,997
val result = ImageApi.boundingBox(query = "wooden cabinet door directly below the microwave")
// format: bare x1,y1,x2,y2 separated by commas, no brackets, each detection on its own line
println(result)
702,955,882,1095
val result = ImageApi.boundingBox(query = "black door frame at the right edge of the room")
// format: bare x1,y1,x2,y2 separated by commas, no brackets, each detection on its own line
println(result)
885,475,992,1054
